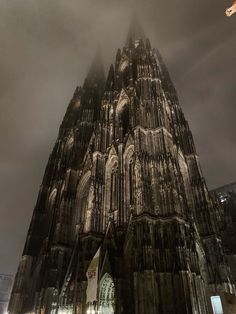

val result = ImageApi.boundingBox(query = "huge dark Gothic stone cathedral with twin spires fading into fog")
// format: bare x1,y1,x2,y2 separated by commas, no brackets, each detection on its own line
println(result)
8,21,236,314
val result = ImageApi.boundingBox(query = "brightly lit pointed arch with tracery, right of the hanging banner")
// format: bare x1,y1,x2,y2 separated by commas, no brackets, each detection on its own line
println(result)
99,273,115,314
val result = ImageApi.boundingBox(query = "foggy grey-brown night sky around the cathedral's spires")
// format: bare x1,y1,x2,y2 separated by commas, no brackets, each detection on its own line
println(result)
0,0,236,273
